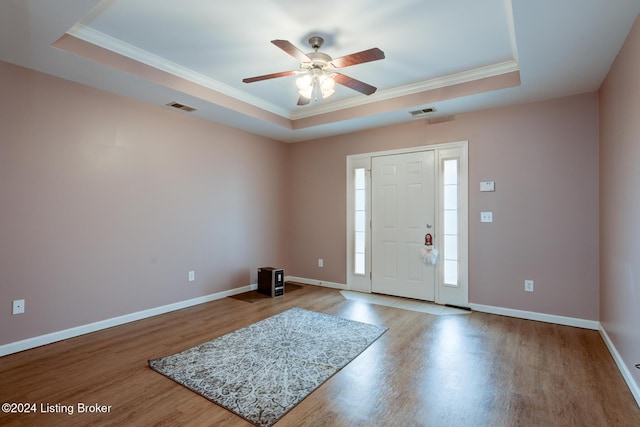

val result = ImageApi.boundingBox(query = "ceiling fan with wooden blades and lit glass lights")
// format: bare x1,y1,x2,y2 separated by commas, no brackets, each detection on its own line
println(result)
242,36,384,105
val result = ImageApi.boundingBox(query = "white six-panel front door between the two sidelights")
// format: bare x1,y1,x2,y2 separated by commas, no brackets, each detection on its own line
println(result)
371,151,436,301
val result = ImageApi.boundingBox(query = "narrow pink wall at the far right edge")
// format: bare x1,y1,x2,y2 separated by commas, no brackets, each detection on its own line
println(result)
599,15,640,387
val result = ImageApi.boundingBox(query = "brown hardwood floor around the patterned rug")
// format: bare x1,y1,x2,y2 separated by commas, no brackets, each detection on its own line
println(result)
0,286,640,427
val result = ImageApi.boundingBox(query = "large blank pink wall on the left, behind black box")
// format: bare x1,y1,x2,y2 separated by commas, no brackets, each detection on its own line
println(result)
0,62,289,345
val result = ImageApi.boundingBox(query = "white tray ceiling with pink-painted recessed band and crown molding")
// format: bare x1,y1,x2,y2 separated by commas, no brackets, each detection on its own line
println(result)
0,0,640,142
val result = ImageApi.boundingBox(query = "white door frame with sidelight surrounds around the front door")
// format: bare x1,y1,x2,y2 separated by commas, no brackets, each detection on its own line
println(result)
346,141,469,307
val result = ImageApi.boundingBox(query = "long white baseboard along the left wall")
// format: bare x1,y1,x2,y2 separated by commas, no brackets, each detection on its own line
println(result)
0,284,258,357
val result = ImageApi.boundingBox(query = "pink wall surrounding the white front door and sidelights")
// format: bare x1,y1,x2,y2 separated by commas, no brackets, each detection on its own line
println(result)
291,94,598,320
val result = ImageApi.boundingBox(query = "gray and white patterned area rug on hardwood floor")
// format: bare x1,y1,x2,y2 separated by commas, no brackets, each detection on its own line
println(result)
149,308,387,426
